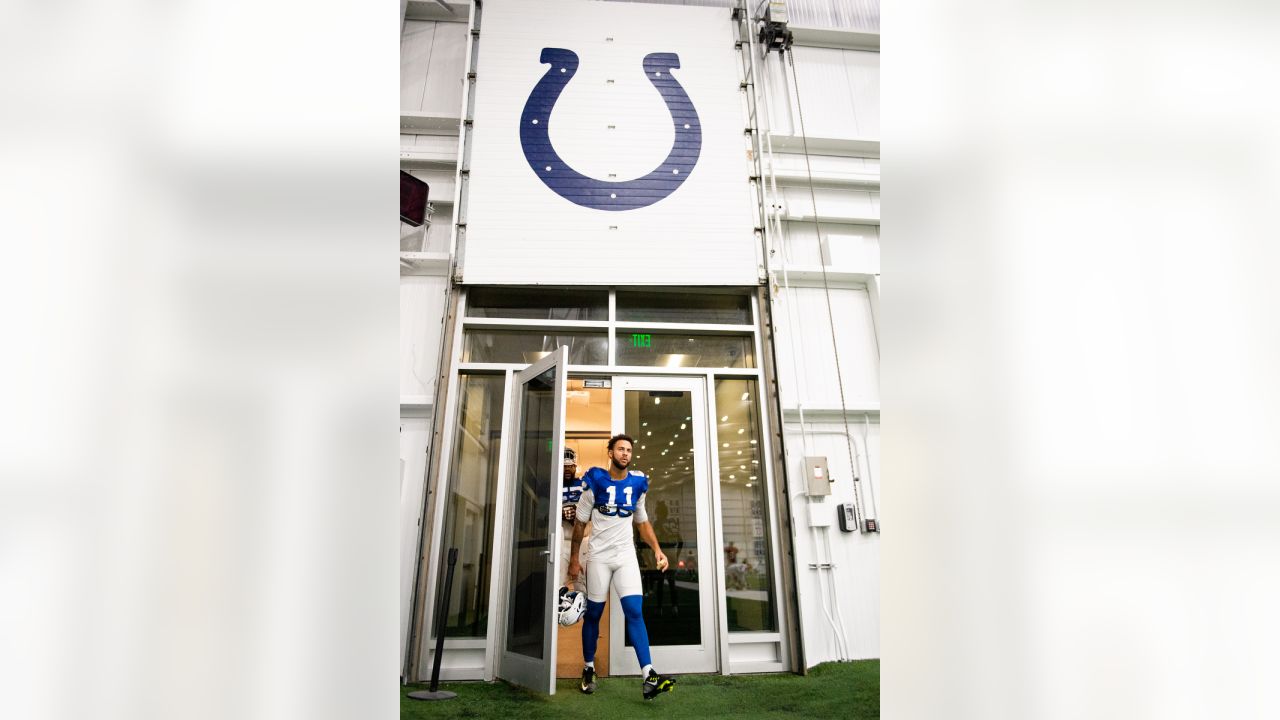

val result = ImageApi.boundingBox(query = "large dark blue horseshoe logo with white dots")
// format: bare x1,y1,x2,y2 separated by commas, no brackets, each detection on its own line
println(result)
520,47,703,211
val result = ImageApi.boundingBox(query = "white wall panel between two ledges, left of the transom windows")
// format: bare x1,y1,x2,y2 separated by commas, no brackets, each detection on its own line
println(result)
399,275,448,398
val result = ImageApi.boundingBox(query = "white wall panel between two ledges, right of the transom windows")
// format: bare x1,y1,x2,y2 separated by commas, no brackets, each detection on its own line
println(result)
774,287,879,407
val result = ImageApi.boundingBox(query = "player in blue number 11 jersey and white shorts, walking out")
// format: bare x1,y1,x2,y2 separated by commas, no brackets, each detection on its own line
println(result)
568,434,675,700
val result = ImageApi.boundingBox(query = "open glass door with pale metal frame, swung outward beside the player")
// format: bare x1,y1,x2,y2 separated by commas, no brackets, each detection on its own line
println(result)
498,346,568,694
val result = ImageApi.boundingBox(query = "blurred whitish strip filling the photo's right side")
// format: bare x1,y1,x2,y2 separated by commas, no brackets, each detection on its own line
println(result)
881,0,1280,720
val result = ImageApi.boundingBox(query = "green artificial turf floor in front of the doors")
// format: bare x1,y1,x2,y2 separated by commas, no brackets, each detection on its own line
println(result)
401,660,879,720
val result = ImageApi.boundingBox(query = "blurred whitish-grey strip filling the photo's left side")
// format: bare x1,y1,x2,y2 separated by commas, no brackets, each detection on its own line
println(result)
0,0,399,720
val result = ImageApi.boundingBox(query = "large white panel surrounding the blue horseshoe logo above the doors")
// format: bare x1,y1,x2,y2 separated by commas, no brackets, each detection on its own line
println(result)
462,0,759,286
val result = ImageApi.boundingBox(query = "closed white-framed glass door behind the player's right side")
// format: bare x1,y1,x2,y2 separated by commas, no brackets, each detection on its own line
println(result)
609,377,719,675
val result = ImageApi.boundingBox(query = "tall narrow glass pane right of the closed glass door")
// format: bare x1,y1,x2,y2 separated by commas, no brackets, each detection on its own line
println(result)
716,379,778,632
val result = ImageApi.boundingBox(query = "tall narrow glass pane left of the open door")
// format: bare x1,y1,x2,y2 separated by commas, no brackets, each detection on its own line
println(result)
433,375,506,638
